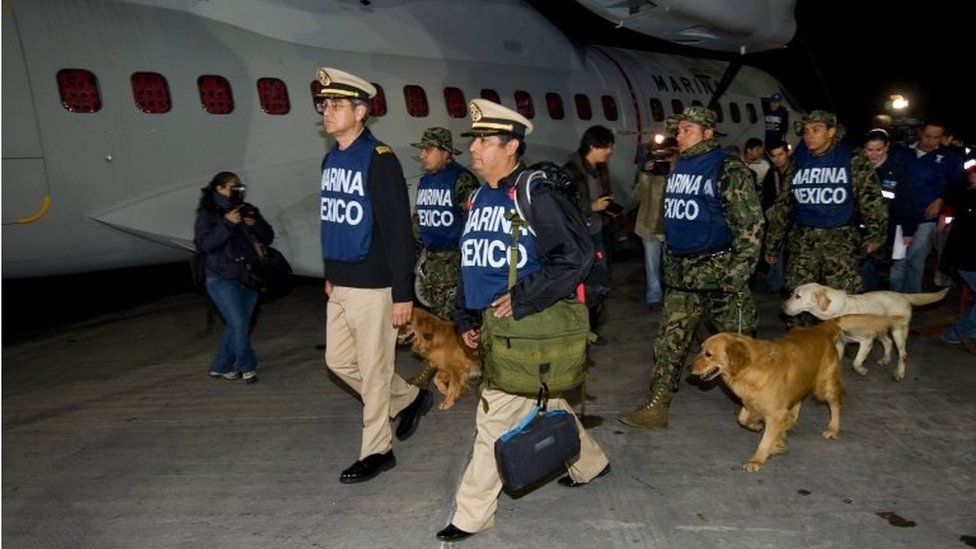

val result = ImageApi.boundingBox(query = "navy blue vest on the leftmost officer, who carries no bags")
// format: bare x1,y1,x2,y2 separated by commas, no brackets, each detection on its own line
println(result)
320,130,380,263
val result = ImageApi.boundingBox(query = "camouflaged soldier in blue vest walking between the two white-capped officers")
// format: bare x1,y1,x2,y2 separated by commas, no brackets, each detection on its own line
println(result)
410,128,478,387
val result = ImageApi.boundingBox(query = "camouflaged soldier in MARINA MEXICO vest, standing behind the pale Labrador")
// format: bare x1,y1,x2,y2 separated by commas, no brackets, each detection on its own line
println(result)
766,111,888,293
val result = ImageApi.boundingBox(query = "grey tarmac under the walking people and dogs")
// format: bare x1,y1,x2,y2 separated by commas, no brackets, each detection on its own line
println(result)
2,261,976,549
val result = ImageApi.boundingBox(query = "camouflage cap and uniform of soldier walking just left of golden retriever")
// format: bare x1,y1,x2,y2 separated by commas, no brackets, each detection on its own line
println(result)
619,107,764,428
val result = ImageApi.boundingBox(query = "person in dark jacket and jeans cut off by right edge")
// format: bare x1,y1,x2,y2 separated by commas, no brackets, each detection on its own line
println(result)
939,155,976,353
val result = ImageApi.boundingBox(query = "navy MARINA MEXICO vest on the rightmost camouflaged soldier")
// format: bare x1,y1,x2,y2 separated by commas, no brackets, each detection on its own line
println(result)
790,142,854,229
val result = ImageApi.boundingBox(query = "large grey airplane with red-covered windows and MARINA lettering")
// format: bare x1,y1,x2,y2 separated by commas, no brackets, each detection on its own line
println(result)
2,0,798,278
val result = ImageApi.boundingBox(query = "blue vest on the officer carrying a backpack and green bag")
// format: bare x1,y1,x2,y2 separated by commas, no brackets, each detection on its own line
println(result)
461,185,539,310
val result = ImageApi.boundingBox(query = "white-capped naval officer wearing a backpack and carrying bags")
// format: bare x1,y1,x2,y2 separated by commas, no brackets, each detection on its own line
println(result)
437,99,610,541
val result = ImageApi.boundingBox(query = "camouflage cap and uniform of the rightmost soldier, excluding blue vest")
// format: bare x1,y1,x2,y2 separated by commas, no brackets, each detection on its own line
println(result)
766,111,888,293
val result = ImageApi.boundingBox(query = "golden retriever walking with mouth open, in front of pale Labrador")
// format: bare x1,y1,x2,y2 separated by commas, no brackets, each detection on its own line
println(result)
691,315,901,471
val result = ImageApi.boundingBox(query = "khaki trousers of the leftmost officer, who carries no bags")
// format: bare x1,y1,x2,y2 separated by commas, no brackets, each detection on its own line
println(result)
325,286,419,459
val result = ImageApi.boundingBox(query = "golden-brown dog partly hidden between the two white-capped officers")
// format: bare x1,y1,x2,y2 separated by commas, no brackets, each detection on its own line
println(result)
397,307,481,410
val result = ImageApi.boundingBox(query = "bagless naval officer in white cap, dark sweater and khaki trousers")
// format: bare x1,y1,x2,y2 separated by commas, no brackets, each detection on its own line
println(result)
318,67,432,484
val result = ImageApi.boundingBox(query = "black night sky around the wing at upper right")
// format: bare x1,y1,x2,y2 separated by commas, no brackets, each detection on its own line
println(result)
529,0,976,143
